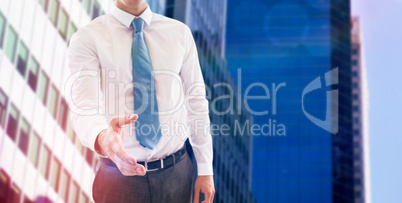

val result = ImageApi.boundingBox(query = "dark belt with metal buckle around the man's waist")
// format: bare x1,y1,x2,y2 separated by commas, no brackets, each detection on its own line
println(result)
99,144,187,171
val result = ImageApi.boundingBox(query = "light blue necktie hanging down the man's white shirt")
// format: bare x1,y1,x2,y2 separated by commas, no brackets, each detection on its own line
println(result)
132,18,162,149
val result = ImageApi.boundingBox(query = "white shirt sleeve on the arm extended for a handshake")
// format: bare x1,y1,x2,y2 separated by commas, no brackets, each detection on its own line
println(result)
65,30,109,151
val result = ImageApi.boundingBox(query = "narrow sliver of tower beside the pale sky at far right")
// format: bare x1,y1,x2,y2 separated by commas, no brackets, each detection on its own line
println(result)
351,18,371,203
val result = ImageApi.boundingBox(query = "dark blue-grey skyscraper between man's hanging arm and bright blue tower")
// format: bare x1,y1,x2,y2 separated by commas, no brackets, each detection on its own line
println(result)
165,0,255,202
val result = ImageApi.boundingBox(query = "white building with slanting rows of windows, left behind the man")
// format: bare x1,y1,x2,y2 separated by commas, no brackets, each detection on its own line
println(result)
0,0,165,203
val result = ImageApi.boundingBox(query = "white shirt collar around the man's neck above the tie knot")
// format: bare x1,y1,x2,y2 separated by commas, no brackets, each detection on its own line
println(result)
111,3,152,27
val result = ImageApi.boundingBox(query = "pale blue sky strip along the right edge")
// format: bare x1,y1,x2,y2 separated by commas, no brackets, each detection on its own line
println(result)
352,0,402,203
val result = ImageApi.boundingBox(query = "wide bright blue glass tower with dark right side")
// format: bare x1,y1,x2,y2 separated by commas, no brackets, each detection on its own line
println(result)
226,0,355,202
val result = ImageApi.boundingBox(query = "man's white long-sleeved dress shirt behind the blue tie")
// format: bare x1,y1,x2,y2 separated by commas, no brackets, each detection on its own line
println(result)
65,2,213,175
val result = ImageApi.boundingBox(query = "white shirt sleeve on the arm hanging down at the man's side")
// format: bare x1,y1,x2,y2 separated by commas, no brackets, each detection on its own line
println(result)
180,26,213,175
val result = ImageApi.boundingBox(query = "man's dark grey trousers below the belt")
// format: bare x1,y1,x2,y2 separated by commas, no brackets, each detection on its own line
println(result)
92,153,195,203
